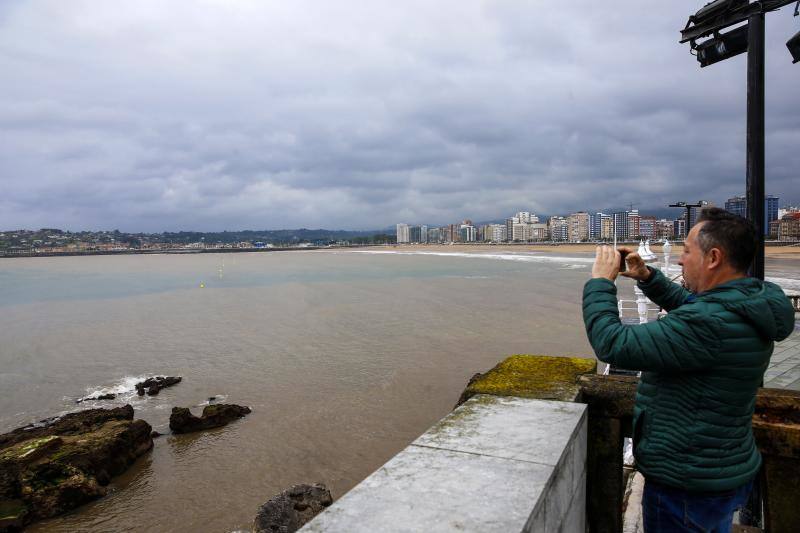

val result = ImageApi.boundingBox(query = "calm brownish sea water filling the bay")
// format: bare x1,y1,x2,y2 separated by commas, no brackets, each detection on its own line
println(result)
0,251,800,532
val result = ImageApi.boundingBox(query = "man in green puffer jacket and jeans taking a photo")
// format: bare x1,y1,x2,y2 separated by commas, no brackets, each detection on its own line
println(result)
583,208,794,532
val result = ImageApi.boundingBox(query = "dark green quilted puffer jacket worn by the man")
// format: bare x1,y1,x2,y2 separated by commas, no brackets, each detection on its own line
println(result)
583,269,794,492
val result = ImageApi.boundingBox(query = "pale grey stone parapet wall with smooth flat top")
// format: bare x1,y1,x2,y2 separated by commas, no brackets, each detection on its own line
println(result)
302,395,587,533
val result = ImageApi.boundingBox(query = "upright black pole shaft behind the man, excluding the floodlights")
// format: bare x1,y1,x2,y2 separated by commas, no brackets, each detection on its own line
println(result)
747,13,764,279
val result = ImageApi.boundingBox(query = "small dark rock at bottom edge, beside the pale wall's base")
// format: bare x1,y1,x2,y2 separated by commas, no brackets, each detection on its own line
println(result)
253,483,333,533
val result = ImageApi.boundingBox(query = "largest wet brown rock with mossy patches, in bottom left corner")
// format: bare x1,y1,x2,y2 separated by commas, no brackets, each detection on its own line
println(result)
0,405,153,532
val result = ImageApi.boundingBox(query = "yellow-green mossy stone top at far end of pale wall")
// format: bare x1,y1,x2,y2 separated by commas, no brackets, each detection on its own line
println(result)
456,355,597,407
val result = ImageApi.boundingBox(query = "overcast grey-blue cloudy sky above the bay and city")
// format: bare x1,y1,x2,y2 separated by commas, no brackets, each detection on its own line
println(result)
0,0,800,231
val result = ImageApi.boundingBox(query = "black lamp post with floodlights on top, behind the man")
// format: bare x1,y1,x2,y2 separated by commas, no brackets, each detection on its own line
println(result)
680,0,800,279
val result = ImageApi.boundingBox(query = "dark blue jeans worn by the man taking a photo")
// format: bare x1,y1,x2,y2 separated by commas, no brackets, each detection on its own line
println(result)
642,480,753,533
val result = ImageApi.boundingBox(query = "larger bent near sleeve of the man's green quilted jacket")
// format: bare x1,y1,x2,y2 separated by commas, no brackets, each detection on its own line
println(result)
583,279,721,372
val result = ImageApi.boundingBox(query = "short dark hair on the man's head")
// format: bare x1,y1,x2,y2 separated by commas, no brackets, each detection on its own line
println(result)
697,207,756,272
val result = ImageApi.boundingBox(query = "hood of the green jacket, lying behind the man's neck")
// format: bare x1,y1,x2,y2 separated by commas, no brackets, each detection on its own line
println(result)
699,278,794,341
